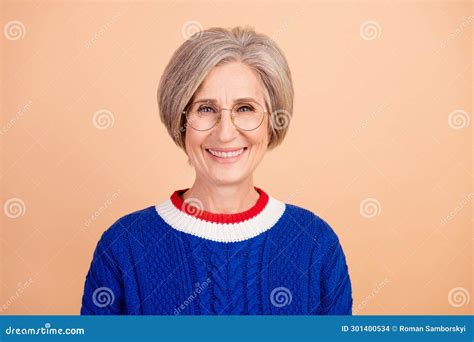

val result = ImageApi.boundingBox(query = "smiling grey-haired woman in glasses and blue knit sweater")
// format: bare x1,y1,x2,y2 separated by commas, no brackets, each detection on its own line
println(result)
81,27,352,315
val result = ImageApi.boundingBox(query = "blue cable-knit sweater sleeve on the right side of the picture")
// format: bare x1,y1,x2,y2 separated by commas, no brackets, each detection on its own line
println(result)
319,221,353,315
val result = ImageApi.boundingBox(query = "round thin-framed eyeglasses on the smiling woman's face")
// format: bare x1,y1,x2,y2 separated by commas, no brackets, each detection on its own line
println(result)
183,101,267,131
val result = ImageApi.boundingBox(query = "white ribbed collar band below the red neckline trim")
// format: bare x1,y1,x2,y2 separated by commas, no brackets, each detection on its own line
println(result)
155,196,286,242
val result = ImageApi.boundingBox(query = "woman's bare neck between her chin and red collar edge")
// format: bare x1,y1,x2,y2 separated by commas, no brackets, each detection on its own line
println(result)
182,177,260,214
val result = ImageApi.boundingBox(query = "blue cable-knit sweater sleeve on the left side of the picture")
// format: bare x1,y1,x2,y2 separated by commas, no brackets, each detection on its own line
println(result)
81,229,124,315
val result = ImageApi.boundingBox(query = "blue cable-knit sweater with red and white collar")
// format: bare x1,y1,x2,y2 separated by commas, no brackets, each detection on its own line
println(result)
81,188,352,315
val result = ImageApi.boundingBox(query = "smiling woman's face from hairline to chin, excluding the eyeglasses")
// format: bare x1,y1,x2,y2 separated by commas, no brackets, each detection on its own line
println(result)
185,62,269,185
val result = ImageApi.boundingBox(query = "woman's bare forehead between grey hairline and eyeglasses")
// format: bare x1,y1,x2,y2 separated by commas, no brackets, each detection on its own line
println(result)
194,62,263,102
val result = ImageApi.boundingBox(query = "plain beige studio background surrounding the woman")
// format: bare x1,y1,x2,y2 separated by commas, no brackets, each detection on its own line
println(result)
0,1,474,315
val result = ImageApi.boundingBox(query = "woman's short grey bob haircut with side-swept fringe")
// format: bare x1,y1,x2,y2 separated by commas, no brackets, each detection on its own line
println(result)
157,26,294,152
